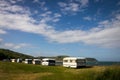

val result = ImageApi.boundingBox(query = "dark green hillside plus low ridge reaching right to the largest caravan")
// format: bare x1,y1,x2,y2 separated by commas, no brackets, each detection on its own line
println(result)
0,49,68,61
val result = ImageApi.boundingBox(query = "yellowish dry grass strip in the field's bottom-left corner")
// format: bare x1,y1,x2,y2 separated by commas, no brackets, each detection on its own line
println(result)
0,73,52,80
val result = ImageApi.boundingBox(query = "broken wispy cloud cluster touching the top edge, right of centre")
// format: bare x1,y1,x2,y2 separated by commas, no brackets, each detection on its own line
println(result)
58,0,89,14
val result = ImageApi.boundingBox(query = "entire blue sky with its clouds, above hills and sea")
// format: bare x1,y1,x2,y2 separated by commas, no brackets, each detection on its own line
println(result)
0,0,120,61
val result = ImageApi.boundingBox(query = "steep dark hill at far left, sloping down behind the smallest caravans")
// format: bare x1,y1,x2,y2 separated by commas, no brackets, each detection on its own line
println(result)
0,49,33,60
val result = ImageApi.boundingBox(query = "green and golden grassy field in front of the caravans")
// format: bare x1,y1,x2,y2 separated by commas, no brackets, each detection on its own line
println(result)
0,62,120,80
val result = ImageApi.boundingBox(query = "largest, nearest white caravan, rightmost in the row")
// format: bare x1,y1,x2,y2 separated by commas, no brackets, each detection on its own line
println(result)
63,57,86,68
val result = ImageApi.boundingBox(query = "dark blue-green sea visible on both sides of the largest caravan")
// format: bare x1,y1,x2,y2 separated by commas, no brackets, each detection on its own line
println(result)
56,61,120,66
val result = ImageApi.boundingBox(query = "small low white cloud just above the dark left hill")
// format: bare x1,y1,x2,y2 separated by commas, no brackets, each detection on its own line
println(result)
2,43,30,49
